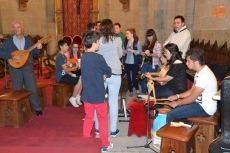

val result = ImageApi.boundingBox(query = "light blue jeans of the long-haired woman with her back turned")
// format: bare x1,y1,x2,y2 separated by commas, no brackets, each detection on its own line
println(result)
94,75,121,132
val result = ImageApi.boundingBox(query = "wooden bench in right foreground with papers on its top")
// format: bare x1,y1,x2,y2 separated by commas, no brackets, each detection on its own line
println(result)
157,123,198,153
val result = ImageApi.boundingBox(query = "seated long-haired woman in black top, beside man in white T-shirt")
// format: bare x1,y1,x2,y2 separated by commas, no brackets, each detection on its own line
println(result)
146,43,187,98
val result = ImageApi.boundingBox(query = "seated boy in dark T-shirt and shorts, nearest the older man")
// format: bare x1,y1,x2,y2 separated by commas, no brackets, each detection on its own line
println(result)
55,39,82,107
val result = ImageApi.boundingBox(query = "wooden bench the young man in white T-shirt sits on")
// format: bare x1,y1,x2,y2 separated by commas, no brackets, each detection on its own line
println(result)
188,112,220,153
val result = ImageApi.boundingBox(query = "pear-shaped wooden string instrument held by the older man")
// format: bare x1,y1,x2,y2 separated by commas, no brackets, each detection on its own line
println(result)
8,35,51,68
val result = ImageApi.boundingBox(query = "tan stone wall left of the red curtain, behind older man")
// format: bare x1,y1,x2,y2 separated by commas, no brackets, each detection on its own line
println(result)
0,0,57,52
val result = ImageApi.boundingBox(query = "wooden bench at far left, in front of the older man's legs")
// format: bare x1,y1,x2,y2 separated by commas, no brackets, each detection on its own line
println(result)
0,91,31,128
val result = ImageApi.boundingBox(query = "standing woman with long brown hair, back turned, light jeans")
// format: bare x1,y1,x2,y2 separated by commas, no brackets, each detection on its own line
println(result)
95,19,123,137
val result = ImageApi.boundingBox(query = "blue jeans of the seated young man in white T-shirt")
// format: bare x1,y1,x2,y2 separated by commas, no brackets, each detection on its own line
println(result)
166,102,210,122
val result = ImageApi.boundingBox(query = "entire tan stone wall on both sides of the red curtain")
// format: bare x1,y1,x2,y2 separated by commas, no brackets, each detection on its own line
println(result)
0,0,230,53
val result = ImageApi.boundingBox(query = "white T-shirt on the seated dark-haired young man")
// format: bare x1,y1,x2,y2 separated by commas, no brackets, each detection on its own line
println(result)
194,66,217,115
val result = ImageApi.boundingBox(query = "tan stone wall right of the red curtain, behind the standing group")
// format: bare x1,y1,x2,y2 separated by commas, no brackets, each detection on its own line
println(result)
99,0,230,45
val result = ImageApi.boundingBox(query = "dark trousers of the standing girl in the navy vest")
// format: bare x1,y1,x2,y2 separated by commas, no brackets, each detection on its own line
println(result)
125,64,139,92
